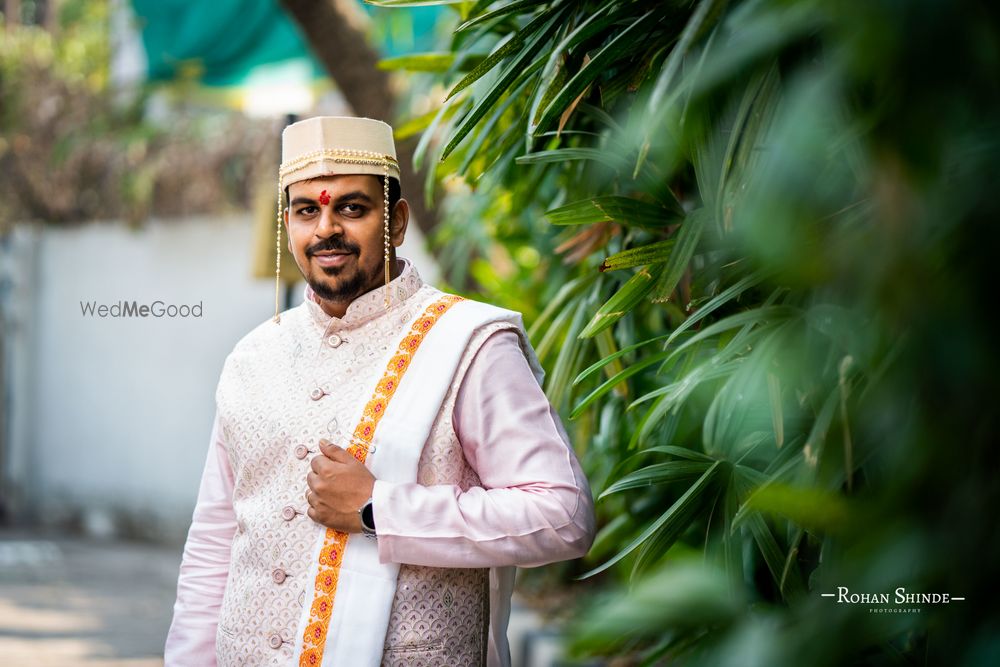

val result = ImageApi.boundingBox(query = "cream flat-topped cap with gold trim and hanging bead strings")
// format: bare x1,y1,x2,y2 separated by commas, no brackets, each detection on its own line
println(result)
274,116,399,323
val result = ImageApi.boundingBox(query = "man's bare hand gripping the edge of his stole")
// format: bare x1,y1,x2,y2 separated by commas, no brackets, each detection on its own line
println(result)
306,440,375,533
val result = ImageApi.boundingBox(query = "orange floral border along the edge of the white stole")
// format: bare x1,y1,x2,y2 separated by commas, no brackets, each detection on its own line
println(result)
299,294,464,667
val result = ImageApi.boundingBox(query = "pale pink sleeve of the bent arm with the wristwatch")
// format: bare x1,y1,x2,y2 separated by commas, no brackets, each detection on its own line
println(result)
372,329,594,567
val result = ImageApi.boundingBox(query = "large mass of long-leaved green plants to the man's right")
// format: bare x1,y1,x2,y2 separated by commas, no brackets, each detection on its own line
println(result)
376,0,1000,666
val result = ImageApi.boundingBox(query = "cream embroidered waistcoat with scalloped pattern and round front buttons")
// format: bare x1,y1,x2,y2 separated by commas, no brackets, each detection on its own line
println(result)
216,266,523,667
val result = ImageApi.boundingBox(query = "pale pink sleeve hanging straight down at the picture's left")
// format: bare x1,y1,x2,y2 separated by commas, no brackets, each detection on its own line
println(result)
164,413,236,667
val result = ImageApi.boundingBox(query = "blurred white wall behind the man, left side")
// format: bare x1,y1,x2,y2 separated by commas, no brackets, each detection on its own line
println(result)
0,218,437,540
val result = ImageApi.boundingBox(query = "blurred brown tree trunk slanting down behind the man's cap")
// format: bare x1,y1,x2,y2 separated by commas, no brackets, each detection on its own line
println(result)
281,0,435,235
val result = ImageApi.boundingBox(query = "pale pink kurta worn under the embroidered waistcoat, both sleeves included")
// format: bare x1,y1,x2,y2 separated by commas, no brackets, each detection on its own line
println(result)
166,260,594,667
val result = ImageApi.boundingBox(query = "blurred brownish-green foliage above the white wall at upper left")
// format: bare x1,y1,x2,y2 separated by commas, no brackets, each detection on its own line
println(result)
0,0,276,228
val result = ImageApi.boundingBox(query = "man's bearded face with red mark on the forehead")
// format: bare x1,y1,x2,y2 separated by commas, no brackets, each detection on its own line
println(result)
285,174,405,313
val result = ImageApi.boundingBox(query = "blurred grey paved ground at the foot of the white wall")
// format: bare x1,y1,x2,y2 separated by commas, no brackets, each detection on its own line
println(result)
0,531,580,667
